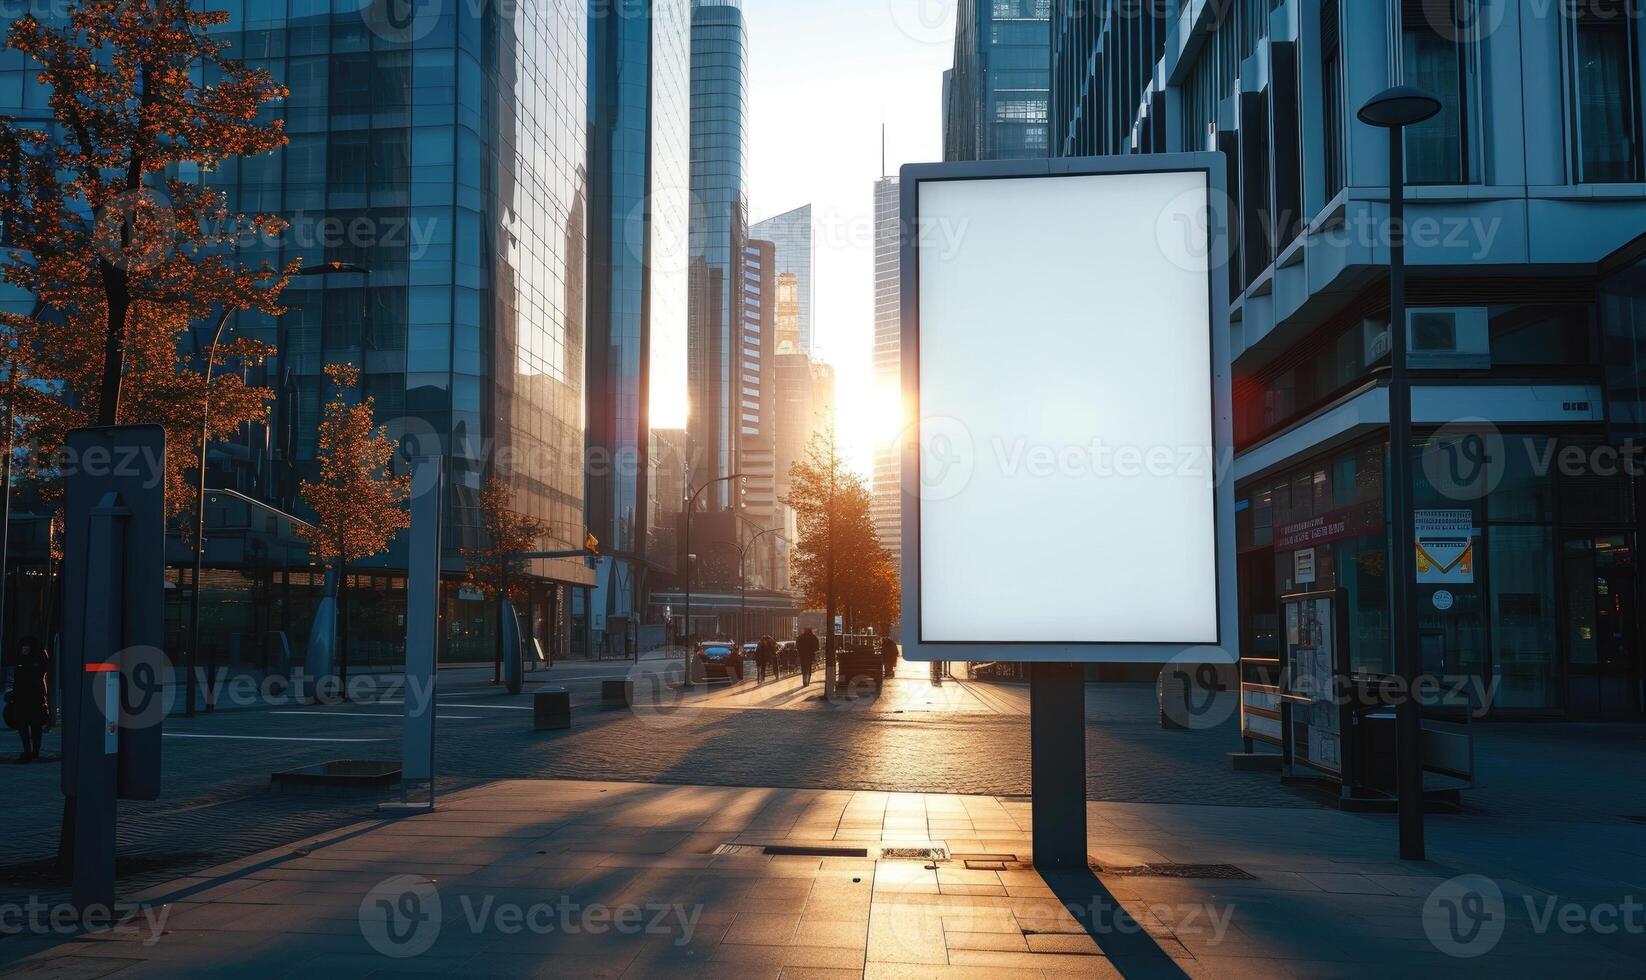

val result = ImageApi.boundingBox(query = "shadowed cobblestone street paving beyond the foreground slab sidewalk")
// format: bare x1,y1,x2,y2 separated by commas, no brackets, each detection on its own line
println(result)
0,664,1646,915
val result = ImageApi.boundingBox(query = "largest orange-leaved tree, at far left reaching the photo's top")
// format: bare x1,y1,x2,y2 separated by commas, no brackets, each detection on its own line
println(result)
0,0,296,516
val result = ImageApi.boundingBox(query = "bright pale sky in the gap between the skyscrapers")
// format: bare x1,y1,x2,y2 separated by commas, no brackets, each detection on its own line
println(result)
744,0,955,474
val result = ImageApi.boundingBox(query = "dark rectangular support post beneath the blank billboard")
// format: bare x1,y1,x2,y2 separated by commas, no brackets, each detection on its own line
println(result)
1029,662,1086,871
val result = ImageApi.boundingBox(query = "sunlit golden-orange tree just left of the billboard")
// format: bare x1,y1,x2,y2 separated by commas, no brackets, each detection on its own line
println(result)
783,425,897,697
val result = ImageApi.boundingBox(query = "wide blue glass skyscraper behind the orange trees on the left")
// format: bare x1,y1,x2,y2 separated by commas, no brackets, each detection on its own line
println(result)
0,0,593,669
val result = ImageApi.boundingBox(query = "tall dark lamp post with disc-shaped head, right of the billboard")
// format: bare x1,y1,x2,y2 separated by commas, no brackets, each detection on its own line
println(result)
1358,86,1440,861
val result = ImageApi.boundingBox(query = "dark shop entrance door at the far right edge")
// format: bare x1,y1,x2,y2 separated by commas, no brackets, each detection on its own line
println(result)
1565,534,1643,718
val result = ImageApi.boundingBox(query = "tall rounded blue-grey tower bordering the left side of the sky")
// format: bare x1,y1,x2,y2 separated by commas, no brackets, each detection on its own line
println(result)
686,0,749,509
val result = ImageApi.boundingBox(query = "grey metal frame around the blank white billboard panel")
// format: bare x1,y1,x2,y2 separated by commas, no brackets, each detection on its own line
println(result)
899,153,1239,664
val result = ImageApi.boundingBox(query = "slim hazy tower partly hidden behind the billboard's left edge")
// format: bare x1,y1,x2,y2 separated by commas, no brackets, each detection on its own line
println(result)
871,176,904,568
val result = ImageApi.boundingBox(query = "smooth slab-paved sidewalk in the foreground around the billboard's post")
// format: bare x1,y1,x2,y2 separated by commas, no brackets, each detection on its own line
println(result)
0,781,1646,980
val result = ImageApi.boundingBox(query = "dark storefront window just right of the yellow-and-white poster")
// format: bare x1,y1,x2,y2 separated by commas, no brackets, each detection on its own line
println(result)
1491,525,1559,708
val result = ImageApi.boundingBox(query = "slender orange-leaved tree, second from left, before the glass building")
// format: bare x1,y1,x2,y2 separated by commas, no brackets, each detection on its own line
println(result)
298,364,412,682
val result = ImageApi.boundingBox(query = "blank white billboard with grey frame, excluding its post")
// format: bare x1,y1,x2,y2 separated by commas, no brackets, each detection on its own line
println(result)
902,153,1238,664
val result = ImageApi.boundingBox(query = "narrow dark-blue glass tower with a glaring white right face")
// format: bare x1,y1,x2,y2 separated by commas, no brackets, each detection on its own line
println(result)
574,0,691,652
